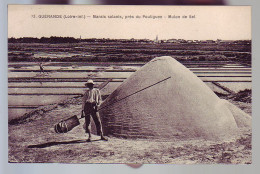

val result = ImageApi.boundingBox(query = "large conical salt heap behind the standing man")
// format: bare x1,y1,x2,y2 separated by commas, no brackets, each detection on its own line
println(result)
100,57,250,140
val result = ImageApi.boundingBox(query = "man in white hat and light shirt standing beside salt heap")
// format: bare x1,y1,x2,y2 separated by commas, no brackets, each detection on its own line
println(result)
81,80,107,142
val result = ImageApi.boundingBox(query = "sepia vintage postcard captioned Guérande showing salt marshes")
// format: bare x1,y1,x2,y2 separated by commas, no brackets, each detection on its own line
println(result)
8,5,252,164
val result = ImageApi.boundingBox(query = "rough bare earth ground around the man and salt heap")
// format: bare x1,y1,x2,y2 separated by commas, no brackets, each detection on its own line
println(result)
9,95,252,164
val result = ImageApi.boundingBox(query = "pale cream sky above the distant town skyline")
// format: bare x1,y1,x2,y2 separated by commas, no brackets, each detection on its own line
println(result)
8,5,251,40
